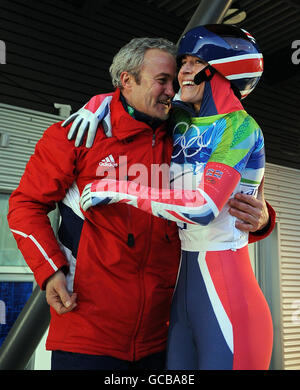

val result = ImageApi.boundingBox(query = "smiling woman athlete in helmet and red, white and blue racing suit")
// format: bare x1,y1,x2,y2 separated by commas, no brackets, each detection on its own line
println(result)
68,25,272,370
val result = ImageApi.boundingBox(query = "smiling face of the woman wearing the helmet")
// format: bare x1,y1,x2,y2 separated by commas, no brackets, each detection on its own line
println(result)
178,55,208,112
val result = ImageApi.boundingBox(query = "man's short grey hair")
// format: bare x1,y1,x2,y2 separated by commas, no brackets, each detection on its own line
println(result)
109,38,176,88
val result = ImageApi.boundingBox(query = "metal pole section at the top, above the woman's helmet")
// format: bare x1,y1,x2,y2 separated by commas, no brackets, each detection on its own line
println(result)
178,0,233,42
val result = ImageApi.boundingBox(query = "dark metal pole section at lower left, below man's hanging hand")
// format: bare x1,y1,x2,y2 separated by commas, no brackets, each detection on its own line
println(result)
0,286,50,370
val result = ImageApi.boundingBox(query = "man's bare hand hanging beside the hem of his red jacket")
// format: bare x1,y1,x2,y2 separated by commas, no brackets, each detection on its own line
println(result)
46,270,77,314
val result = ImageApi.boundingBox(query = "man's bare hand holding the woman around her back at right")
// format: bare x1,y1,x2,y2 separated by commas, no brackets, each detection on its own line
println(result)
229,181,269,232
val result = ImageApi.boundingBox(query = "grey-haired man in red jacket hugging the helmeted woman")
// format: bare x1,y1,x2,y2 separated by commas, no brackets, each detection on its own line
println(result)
8,38,274,369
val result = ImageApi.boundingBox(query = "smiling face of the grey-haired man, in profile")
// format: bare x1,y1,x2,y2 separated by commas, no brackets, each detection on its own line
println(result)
123,49,176,120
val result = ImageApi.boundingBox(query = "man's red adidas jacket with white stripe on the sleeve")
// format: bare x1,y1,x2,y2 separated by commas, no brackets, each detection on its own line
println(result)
8,90,274,360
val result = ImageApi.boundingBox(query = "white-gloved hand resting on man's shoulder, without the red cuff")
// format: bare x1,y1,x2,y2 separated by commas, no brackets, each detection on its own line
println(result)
62,107,100,148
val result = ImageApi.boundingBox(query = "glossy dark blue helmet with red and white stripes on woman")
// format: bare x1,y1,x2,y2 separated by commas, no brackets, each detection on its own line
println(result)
177,24,263,99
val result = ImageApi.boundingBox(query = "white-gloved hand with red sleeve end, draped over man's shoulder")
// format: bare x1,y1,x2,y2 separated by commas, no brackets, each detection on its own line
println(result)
62,94,112,148
